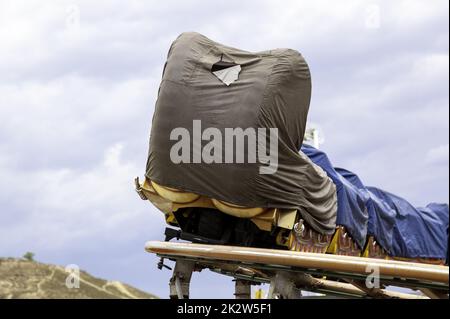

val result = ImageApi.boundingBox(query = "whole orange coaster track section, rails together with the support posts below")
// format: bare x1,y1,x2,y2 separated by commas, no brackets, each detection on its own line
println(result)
146,242,448,299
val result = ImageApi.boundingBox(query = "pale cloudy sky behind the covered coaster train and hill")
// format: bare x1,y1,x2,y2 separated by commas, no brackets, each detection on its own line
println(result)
0,0,449,297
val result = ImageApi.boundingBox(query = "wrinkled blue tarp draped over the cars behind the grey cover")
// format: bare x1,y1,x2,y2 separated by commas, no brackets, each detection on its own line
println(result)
301,144,449,259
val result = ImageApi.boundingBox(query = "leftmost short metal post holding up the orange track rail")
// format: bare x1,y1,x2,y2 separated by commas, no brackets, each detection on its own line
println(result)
169,260,195,299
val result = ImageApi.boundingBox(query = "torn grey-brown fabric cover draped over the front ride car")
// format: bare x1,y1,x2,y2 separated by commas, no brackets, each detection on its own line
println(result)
146,33,337,234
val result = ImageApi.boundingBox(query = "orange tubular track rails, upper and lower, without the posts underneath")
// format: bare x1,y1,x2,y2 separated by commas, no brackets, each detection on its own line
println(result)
145,241,449,298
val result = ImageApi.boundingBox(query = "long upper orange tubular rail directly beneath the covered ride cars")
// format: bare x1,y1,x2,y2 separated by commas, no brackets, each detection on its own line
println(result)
146,241,449,286
